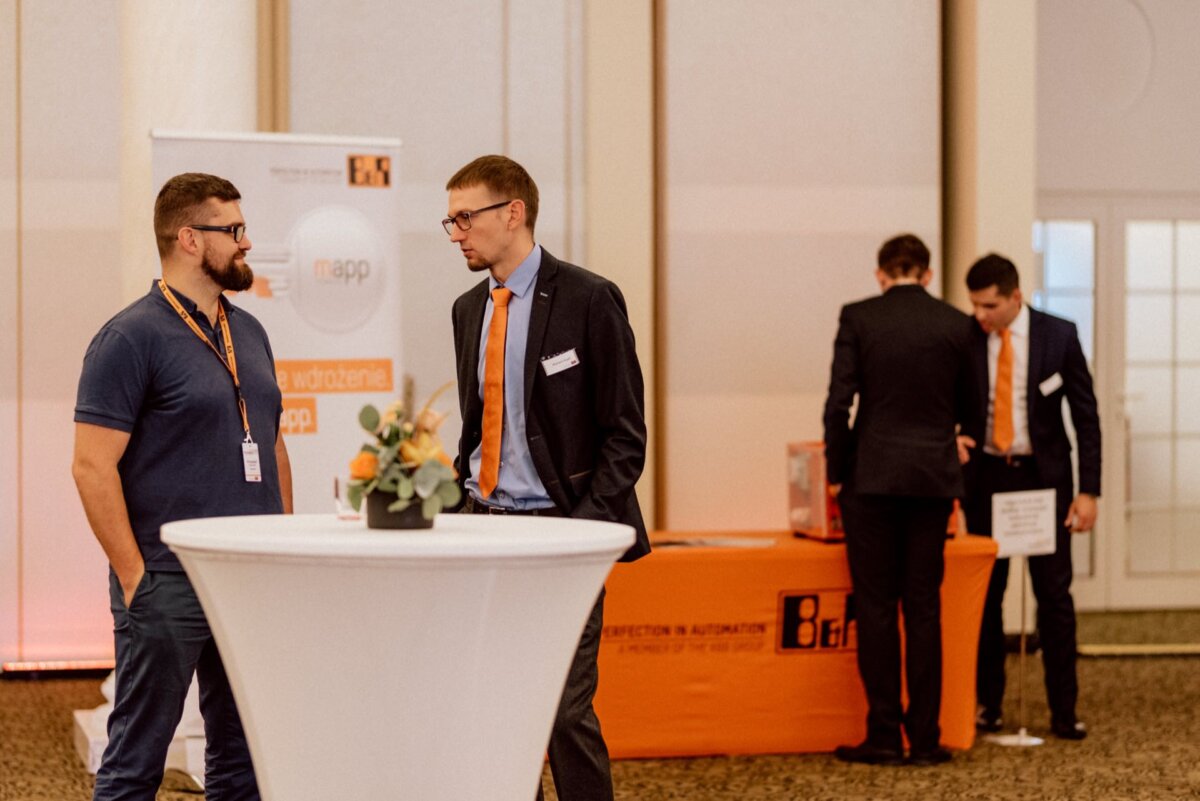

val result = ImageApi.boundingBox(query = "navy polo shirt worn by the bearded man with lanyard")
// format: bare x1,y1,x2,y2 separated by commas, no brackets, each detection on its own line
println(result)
74,282,283,571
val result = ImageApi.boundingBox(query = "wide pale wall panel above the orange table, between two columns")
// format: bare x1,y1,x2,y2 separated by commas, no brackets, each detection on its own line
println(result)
660,0,941,529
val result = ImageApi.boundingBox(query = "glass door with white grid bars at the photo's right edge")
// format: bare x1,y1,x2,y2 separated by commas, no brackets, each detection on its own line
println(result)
1117,215,1200,607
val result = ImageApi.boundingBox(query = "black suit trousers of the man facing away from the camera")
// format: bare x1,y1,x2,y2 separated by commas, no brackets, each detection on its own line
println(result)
840,492,953,752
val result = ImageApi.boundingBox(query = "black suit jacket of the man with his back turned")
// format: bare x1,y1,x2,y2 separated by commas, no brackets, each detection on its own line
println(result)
824,284,972,498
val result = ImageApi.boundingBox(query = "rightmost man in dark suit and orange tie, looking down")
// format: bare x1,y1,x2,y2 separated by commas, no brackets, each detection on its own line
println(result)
962,253,1100,740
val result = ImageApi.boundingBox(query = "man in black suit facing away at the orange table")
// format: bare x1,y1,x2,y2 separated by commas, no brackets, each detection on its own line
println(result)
824,234,971,765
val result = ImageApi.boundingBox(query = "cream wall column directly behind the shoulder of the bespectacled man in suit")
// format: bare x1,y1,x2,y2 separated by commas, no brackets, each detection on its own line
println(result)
583,0,658,526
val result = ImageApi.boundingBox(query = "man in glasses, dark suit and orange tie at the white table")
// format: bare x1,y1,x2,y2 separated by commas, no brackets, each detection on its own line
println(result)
442,156,650,801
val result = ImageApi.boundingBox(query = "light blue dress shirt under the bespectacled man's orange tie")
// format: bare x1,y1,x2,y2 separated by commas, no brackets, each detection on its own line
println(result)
467,245,554,510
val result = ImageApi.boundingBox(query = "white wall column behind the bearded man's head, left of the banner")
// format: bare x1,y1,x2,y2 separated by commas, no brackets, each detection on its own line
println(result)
120,0,258,301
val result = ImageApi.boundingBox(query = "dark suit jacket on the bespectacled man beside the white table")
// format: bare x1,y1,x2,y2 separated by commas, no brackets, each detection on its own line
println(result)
454,248,650,561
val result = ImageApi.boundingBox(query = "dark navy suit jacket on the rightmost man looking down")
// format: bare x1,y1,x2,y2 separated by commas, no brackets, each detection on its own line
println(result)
966,308,1100,496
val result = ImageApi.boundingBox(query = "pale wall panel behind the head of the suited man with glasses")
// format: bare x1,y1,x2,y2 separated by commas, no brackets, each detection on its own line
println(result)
290,0,587,460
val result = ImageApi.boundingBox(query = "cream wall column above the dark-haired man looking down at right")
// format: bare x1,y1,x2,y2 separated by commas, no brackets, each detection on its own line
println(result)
942,0,1037,307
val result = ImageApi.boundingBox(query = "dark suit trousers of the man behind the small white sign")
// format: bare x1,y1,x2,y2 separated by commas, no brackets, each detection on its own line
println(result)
964,453,1079,724
